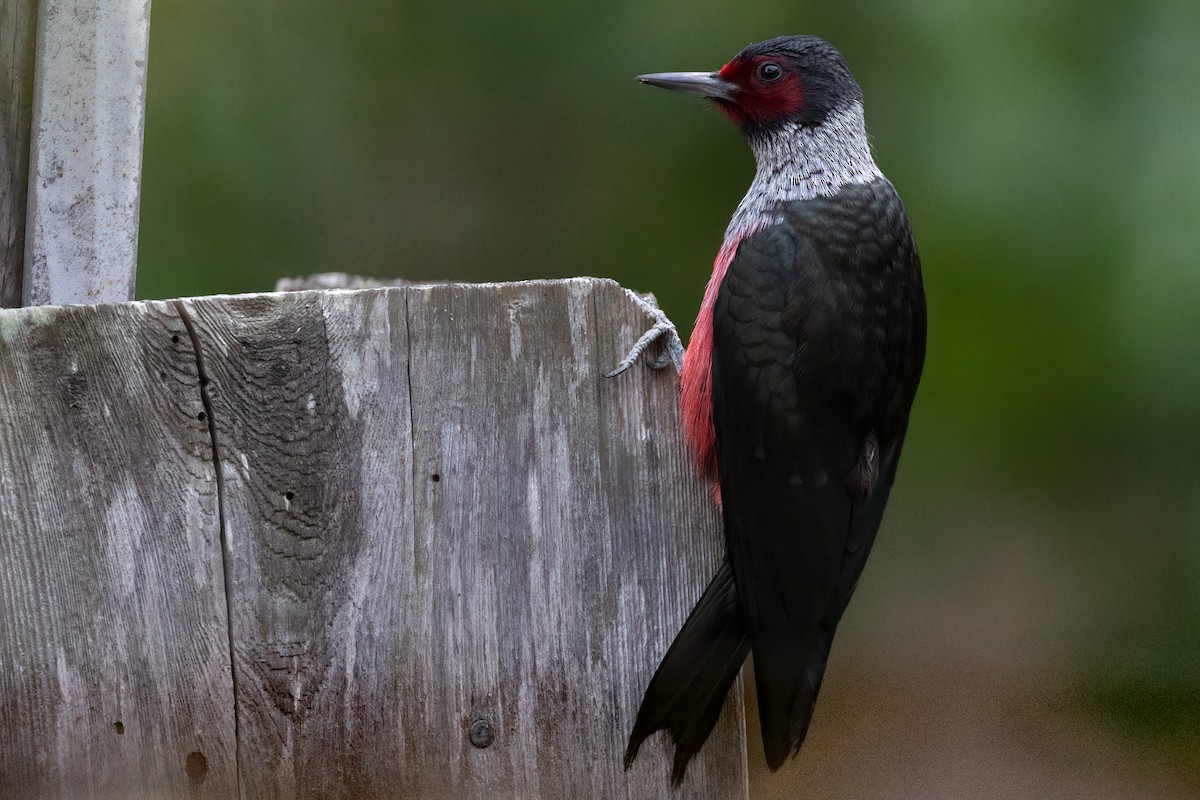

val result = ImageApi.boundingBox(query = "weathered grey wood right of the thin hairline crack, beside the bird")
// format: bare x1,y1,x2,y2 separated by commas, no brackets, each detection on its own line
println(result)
404,279,745,798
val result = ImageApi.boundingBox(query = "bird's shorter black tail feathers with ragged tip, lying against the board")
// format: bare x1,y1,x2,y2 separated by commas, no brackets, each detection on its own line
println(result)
625,559,750,786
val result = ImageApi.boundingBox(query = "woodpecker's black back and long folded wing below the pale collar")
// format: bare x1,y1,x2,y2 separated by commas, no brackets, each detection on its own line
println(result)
713,181,925,769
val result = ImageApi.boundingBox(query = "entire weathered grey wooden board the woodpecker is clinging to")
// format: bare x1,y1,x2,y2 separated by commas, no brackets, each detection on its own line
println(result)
0,278,746,800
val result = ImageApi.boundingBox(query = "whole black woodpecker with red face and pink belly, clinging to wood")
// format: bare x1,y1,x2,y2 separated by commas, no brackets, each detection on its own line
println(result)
617,36,925,783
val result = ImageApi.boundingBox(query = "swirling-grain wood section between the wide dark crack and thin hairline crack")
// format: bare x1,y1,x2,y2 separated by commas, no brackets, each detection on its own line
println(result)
186,290,417,798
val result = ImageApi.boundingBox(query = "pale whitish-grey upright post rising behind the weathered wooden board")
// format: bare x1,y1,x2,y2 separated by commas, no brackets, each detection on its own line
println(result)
24,0,150,306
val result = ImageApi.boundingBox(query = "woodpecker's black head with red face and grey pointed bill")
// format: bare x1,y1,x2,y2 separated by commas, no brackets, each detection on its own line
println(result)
637,36,863,137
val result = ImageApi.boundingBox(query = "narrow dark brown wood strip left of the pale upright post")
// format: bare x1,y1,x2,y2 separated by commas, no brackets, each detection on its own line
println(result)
0,0,37,308
